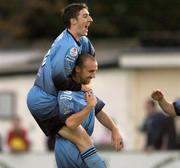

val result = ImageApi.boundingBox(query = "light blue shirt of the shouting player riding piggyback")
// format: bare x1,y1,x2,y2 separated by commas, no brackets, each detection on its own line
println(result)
35,30,95,96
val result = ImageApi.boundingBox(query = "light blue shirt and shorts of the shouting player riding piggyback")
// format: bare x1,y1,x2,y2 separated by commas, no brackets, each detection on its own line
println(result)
27,29,95,135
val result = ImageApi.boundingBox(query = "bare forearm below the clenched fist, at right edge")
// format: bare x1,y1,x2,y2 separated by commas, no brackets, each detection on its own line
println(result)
158,98,176,116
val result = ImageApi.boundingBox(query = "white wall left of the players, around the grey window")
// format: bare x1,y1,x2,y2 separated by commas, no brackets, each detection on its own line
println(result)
0,75,45,151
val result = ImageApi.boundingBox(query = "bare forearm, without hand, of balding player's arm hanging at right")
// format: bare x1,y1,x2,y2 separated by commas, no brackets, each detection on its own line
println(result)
96,111,117,131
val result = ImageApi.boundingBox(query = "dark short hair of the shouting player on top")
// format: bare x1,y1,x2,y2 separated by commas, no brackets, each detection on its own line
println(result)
62,3,88,28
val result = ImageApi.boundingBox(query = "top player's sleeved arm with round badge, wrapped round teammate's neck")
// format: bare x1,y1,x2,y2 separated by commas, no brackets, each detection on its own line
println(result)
52,45,92,91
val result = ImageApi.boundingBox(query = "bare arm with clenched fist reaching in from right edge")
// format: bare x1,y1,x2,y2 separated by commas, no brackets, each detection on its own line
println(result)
151,90,176,117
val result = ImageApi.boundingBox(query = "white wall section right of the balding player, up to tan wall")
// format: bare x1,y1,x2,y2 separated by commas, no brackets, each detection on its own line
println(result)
93,69,133,149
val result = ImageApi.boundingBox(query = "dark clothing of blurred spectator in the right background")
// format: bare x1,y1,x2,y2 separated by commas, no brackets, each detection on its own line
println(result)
142,112,176,150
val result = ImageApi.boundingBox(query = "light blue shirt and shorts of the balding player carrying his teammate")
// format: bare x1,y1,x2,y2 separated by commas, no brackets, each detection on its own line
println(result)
55,91,95,168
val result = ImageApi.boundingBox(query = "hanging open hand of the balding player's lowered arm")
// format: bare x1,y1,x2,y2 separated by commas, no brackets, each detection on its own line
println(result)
111,128,124,151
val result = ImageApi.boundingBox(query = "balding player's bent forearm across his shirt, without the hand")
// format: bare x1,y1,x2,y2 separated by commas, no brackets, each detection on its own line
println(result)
66,106,93,129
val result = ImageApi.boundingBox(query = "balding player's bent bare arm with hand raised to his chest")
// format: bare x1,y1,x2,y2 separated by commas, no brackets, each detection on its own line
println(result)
65,92,97,129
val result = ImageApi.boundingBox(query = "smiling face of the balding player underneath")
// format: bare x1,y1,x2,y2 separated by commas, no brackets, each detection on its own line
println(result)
77,60,98,84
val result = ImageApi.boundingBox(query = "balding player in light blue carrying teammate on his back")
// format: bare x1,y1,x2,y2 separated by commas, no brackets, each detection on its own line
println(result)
55,54,123,168
